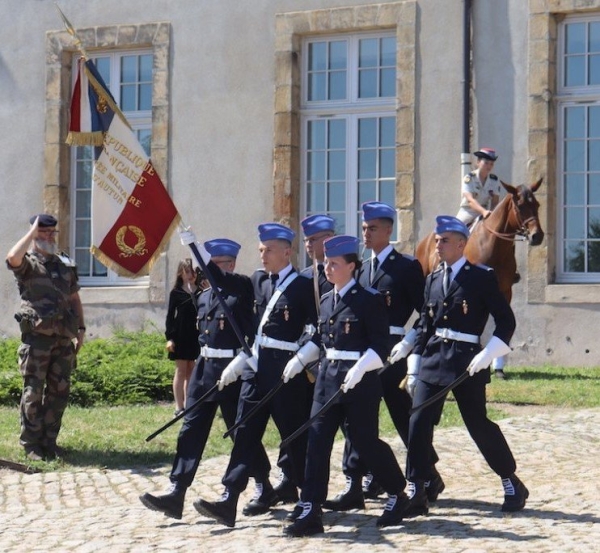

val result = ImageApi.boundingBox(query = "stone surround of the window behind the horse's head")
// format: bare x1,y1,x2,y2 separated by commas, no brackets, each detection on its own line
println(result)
527,0,600,304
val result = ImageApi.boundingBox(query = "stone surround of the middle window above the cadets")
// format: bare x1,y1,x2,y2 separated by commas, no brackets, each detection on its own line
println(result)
273,0,417,251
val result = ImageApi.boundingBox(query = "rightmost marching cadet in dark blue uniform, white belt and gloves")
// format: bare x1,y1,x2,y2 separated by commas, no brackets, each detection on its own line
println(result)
408,216,529,511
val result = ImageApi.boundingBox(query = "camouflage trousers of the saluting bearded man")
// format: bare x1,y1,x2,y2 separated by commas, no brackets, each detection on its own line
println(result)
18,334,76,448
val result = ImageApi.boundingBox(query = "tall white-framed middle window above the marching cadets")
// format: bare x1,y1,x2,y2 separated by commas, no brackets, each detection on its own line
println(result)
301,32,398,240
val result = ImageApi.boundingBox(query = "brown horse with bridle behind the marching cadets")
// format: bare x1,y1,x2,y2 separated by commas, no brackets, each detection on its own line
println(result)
416,179,544,302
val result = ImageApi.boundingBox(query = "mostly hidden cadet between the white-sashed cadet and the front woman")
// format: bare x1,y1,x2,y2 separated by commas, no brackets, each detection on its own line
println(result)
275,214,335,503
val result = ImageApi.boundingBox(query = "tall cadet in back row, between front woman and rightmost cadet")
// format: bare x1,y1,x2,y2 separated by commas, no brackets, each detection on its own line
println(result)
323,202,445,515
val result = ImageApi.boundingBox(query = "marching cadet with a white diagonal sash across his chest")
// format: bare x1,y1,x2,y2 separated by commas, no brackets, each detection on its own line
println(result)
194,223,316,527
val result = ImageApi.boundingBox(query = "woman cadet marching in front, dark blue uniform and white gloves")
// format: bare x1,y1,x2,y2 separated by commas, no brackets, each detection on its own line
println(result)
283,236,409,536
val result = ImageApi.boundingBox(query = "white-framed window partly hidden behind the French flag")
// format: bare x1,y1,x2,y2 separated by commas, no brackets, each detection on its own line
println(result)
71,50,153,286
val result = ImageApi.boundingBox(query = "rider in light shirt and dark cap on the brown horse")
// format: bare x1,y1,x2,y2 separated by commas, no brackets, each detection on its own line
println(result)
456,148,500,226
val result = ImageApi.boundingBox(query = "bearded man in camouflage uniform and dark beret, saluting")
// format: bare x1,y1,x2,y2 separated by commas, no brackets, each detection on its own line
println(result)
6,213,85,461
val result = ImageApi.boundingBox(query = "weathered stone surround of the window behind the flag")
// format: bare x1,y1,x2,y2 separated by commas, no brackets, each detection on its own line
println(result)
43,22,171,305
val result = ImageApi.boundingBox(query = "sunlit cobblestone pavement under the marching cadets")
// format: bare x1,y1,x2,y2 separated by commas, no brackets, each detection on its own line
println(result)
0,409,600,553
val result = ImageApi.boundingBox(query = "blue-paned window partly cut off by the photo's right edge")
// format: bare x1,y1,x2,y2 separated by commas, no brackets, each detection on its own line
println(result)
557,16,600,283
